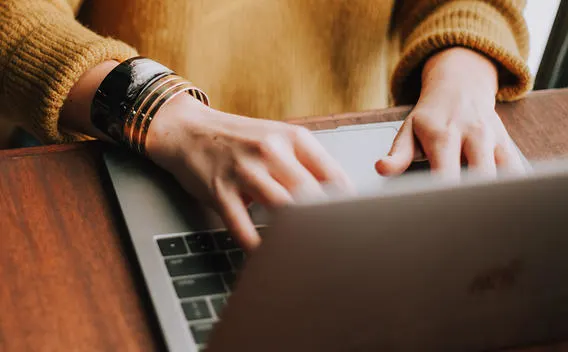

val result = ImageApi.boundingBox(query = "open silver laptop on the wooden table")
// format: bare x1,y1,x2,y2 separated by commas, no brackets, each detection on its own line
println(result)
105,122,568,351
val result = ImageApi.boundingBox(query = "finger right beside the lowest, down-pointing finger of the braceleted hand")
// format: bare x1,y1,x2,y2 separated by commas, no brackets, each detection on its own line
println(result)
237,163,293,208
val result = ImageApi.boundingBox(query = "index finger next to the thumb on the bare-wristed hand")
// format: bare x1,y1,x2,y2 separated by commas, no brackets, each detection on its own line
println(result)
418,130,461,180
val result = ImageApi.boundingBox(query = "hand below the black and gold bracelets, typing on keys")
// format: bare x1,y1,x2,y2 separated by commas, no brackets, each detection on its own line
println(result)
146,94,353,250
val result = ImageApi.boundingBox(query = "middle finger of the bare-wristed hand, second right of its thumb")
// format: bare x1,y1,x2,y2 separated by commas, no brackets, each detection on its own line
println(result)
463,138,497,177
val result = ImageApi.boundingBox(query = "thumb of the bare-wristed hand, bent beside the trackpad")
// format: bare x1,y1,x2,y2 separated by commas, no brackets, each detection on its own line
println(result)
375,119,415,176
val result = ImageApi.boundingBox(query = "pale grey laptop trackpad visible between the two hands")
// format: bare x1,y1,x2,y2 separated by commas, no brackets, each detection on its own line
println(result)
314,123,398,190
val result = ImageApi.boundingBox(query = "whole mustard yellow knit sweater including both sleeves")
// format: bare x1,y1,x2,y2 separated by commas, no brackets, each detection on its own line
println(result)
0,0,531,142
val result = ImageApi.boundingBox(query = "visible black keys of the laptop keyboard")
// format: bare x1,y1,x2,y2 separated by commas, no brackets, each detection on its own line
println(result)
156,226,264,348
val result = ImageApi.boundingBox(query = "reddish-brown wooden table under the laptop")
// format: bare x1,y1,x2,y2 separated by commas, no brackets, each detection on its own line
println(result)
0,90,568,352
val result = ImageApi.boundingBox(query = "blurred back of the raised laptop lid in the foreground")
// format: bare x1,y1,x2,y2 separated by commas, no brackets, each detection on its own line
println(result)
210,163,568,351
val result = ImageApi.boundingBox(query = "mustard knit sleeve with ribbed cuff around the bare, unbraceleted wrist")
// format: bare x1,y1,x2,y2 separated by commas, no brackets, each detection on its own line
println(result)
391,0,532,104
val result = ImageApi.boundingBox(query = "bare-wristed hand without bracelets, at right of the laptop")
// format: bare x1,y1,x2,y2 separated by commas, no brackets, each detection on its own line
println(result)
375,48,524,179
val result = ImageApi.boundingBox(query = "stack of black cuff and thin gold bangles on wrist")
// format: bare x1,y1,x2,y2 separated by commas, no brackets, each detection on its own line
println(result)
91,57,209,154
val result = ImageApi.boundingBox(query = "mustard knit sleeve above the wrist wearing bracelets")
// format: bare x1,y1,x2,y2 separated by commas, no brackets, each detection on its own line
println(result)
0,0,136,143
